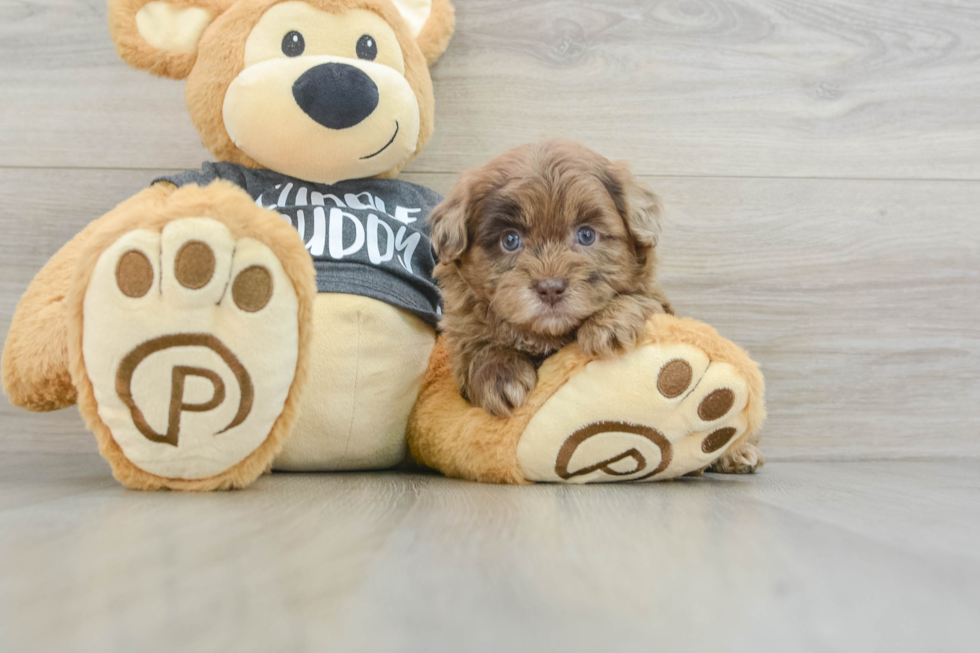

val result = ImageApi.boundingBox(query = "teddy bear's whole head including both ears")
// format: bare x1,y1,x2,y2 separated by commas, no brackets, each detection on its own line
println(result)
109,0,454,183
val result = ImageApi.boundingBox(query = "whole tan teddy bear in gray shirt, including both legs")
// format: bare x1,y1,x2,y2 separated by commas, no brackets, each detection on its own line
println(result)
2,0,764,490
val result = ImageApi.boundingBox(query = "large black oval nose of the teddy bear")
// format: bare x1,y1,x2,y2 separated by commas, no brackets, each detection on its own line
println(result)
293,63,378,129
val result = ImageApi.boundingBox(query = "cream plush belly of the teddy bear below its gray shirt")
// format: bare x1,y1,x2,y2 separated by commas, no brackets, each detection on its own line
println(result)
273,293,435,471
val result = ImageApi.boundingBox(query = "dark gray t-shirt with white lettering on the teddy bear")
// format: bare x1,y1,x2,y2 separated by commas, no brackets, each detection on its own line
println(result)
153,162,442,326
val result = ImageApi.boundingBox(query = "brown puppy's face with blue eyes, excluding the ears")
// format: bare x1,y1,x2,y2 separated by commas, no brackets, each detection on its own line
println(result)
461,173,635,335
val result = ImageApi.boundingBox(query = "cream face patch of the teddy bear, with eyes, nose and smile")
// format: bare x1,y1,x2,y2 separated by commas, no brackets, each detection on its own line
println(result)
222,0,420,183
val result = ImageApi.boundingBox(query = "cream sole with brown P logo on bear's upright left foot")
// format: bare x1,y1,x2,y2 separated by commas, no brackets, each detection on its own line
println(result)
82,218,299,479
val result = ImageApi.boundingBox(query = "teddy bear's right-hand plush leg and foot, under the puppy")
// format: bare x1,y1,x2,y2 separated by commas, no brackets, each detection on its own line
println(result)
408,315,765,483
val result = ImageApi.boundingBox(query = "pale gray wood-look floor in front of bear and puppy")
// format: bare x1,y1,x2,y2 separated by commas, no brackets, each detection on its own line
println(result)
0,454,980,652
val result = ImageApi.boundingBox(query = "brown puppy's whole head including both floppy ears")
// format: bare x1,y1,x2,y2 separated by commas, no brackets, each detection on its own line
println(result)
431,141,660,336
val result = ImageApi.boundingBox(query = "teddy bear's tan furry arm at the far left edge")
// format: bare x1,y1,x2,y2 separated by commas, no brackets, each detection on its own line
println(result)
2,183,175,411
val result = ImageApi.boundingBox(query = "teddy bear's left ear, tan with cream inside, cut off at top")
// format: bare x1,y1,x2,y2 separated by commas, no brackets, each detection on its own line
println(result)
109,0,234,79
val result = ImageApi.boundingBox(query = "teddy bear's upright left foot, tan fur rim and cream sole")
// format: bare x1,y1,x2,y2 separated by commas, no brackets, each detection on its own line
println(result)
67,183,315,490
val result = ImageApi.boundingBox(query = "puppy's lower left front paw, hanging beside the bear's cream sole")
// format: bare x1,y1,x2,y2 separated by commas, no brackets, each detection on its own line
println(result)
469,352,538,417
